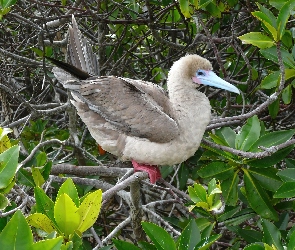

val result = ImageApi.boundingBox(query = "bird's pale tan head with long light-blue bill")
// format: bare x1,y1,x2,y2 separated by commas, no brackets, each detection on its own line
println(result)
169,55,240,94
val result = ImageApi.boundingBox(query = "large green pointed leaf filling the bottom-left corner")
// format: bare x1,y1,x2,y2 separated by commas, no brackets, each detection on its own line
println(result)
0,210,33,250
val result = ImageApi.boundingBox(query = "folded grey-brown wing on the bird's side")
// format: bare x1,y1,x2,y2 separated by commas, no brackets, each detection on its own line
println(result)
71,76,179,143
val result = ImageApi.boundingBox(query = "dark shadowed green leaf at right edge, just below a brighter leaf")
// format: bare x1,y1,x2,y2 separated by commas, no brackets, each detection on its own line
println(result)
247,145,294,168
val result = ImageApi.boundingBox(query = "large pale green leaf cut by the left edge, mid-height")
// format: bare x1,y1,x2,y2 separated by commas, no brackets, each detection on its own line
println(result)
0,145,19,189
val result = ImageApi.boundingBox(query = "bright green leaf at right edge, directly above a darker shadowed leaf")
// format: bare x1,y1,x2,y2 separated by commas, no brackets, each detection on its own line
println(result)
249,129,295,152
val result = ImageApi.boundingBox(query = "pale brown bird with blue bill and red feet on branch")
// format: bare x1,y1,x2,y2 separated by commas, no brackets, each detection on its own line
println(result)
48,16,240,183
